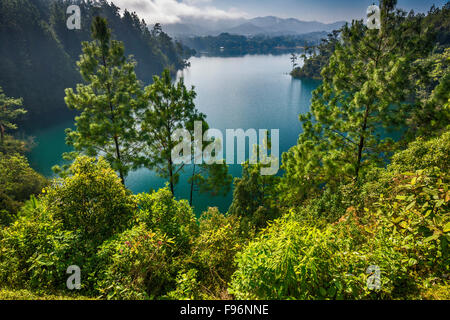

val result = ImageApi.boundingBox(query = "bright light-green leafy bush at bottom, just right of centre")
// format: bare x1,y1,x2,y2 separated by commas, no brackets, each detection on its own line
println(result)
230,217,368,299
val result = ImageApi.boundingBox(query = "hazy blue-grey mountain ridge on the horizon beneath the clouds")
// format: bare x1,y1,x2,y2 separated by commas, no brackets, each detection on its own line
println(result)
163,16,346,37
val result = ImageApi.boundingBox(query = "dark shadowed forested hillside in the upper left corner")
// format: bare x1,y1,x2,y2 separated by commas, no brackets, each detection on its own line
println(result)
0,0,190,123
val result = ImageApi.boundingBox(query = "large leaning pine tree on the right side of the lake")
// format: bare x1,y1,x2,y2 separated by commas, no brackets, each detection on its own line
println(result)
283,0,431,204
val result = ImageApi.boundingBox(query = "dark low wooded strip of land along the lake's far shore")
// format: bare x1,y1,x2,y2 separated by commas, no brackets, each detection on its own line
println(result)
180,32,326,56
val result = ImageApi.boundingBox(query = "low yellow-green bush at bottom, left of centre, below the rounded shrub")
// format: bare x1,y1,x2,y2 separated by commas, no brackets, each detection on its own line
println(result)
97,223,176,300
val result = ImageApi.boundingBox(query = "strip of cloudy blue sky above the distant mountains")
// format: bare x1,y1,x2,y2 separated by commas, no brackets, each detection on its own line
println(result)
113,0,448,24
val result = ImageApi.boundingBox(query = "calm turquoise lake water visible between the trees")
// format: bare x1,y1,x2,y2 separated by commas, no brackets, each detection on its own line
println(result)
29,55,319,213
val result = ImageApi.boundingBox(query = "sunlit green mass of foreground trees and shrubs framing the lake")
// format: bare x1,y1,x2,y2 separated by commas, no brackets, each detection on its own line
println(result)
0,0,450,300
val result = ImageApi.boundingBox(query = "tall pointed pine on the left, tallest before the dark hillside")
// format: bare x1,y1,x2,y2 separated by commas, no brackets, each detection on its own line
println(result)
65,17,143,183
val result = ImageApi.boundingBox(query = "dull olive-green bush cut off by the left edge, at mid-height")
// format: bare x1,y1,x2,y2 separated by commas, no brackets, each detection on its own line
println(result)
0,152,47,226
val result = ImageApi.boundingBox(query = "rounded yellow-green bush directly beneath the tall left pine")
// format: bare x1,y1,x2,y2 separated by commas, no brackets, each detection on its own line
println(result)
42,156,136,245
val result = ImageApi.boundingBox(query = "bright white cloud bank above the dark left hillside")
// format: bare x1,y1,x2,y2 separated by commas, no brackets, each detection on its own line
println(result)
113,0,246,24
